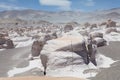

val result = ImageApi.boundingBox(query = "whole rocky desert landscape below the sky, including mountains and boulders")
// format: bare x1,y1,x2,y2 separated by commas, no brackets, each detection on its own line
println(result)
0,8,120,80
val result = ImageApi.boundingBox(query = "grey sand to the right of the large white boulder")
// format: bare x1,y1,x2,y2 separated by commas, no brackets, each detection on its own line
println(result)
91,42,120,80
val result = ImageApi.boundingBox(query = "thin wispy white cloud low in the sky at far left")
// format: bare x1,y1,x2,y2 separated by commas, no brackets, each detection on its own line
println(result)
0,3,25,10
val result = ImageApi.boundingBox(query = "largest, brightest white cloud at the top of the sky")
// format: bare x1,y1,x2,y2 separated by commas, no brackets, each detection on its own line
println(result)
39,0,72,10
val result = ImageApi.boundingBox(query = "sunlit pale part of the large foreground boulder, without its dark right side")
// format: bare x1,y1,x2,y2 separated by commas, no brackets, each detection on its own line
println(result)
41,35,87,77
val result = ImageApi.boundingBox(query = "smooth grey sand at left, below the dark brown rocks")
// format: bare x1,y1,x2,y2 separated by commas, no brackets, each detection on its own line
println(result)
0,47,30,77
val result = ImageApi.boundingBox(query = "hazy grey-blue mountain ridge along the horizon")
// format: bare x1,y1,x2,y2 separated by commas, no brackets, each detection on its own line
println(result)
0,8,120,23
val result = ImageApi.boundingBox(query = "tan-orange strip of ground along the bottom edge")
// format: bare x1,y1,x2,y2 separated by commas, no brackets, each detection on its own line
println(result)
0,76,84,80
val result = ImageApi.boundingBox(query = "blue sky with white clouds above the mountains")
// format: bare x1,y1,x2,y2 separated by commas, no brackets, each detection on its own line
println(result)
0,0,120,11
